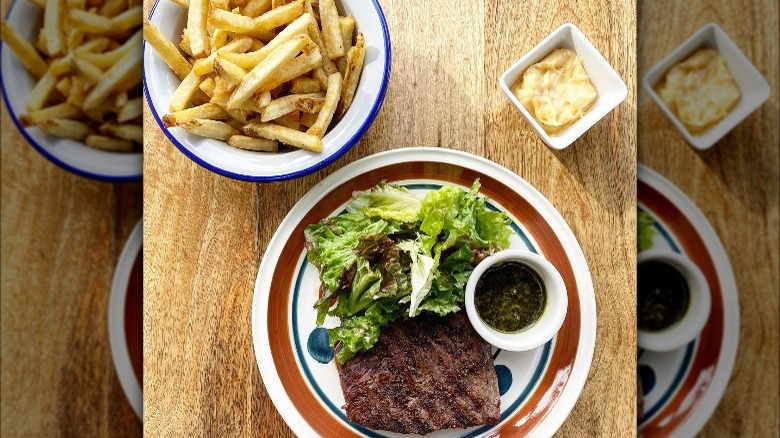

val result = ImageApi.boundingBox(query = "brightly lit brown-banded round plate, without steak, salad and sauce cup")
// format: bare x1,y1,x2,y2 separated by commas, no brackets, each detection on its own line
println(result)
252,148,596,437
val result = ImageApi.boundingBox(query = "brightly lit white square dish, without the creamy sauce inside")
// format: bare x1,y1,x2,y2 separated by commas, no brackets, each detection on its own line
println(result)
499,23,628,149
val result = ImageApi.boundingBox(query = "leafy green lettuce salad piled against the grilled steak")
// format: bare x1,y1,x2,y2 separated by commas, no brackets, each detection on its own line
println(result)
305,180,512,364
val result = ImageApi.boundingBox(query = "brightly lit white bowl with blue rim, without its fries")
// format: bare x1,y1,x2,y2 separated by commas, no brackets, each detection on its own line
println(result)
144,0,390,182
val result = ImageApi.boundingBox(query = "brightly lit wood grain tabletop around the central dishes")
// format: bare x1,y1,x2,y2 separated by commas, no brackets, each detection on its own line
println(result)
144,0,636,437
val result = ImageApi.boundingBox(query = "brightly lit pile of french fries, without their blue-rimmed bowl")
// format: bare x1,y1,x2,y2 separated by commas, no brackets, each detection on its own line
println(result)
144,0,366,152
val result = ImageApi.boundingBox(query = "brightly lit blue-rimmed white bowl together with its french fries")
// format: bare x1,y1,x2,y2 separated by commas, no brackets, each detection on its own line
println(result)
144,0,390,181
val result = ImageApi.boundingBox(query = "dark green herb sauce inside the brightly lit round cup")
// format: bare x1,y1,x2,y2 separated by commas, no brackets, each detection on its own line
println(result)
474,261,547,333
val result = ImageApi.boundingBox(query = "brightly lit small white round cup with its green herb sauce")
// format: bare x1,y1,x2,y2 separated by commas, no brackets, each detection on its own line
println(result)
466,250,569,351
